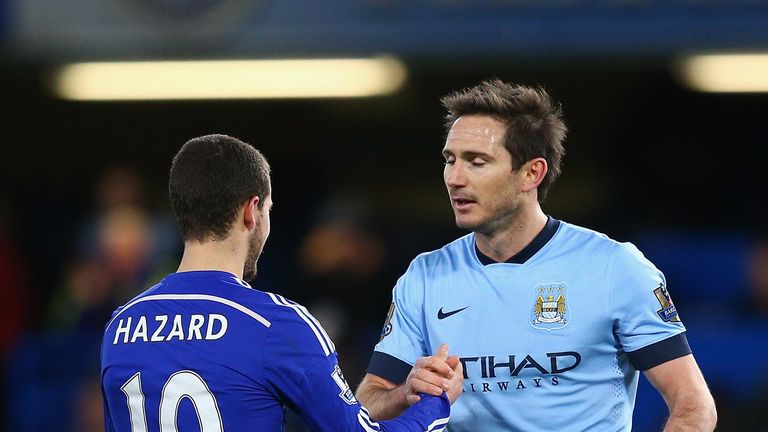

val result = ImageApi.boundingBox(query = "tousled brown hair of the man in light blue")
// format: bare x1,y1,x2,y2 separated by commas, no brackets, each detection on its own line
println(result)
440,80,568,202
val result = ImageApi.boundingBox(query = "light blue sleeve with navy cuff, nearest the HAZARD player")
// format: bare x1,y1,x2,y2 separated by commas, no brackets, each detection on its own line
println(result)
367,261,429,384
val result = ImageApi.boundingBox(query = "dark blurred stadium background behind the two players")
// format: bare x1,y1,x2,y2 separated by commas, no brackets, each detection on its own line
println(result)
0,0,768,431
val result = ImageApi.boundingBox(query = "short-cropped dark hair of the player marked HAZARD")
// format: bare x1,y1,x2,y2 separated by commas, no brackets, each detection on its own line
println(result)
168,135,271,242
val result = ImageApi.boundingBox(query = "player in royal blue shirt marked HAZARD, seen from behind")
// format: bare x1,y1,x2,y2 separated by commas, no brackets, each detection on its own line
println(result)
101,135,463,432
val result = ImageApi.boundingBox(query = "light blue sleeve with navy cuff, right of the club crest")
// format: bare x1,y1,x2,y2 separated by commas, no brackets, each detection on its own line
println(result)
609,243,690,370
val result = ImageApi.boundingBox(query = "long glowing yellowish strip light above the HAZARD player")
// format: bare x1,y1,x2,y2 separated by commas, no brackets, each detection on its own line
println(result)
51,57,406,101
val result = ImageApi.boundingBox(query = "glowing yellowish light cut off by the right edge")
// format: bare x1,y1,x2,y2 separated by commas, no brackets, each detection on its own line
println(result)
677,54,768,93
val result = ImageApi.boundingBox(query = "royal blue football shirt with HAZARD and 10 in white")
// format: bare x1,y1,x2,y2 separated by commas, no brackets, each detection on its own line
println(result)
101,271,450,432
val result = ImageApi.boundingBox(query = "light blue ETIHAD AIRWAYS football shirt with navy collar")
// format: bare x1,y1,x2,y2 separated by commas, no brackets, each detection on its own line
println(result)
368,218,690,432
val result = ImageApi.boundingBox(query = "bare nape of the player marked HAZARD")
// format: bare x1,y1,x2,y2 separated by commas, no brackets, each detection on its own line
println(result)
177,238,246,279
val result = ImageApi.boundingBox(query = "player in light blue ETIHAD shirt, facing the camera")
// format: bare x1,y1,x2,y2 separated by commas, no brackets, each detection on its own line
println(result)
357,80,716,432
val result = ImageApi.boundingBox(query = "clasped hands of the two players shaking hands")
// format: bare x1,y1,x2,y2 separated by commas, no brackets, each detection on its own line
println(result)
405,344,464,405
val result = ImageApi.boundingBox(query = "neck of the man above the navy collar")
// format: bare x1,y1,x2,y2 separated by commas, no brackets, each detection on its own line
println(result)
475,202,547,262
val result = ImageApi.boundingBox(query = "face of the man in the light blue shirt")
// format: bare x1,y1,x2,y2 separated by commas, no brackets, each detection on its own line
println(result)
443,115,522,234
